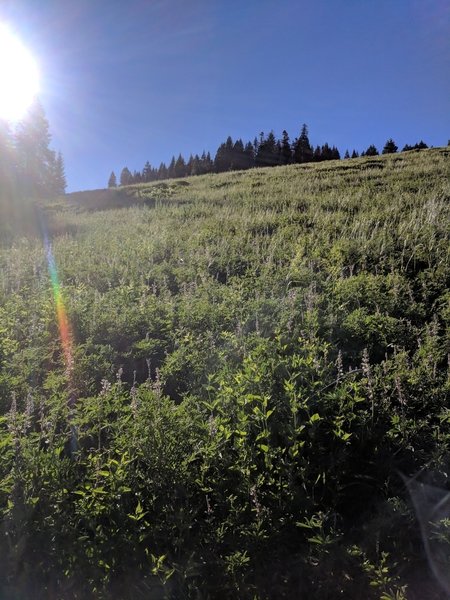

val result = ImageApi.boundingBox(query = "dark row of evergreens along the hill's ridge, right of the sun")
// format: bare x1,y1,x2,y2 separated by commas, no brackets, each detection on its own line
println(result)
108,124,428,187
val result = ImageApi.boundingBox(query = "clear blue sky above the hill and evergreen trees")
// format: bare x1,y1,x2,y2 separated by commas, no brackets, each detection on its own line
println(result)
0,0,450,191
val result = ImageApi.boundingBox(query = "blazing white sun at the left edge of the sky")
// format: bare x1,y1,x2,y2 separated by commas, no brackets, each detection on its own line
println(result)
0,23,39,122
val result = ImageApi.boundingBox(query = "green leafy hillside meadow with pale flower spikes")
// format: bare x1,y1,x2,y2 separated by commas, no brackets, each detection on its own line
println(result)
0,149,450,600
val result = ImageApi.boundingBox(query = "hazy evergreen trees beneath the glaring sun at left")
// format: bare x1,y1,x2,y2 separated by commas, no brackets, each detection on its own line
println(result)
0,101,67,198
